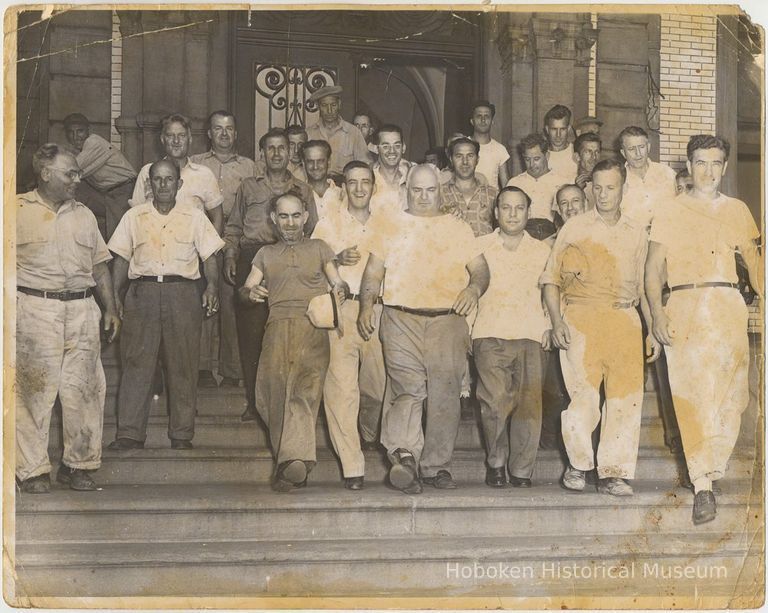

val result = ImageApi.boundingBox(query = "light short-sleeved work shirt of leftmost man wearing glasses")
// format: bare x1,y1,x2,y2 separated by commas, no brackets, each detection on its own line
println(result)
16,190,112,291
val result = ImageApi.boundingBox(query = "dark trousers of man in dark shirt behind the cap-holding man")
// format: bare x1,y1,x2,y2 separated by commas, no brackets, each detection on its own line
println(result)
235,245,269,409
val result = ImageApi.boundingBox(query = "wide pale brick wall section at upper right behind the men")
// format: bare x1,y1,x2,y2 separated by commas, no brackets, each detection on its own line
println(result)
659,14,717,170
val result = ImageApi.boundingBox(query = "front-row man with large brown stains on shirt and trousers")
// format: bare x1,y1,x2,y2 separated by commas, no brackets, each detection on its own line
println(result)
541,160,659,496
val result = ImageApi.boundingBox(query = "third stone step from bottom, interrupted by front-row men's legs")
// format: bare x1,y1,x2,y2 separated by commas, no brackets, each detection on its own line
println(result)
40,447,757,485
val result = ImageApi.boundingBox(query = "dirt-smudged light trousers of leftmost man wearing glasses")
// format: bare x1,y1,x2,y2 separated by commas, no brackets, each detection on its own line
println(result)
16,292,107,481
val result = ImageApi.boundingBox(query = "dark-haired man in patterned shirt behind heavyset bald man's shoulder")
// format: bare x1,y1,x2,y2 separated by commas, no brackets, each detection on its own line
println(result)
441,138,499,236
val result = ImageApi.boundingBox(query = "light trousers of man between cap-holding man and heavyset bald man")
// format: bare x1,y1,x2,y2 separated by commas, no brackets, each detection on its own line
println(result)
323,300,385,477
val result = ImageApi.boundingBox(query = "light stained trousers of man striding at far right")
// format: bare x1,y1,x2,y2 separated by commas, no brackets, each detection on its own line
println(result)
665,287,749,481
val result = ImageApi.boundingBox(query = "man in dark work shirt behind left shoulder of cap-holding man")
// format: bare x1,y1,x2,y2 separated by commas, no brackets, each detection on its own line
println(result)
224,128,317,421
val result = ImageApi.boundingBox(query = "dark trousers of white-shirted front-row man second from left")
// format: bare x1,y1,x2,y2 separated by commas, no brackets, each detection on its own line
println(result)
117,281,203,441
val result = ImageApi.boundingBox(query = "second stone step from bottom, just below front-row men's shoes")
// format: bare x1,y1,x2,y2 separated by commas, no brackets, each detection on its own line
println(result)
16,480,762,544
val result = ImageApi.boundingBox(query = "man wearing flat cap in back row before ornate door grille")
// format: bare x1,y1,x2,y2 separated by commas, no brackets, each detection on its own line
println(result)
307,85,368,177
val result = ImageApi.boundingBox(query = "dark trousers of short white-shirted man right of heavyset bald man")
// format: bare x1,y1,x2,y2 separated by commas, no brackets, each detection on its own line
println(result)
472,338,545,479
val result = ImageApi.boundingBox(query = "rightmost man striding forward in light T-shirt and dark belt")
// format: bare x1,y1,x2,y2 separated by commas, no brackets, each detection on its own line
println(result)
645,134,763,524
